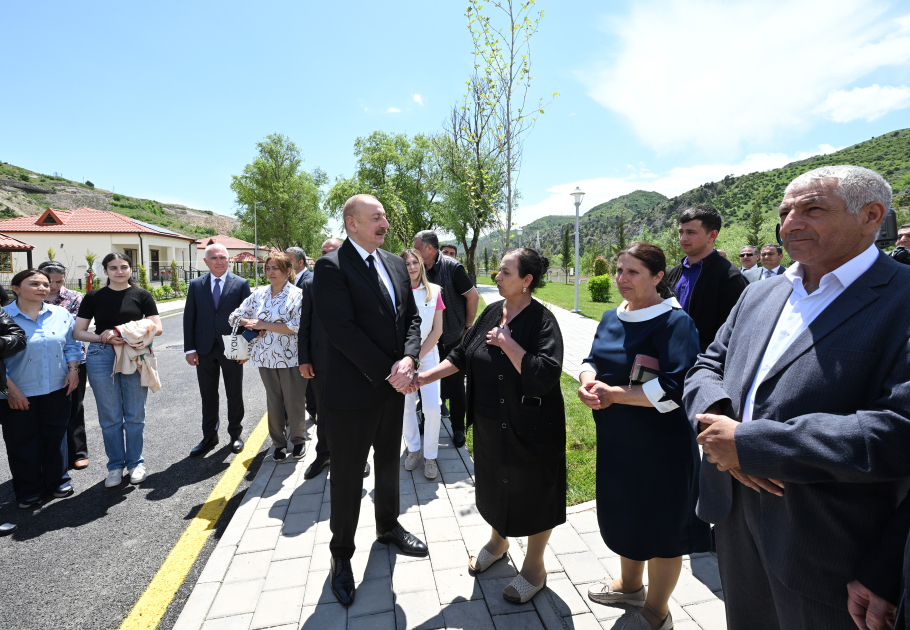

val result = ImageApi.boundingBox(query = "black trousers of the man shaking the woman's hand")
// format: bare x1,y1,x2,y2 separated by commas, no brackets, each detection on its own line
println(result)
319,396,404,559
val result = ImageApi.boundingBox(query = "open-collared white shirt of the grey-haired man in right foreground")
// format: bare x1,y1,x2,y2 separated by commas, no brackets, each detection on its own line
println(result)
743,245,878,422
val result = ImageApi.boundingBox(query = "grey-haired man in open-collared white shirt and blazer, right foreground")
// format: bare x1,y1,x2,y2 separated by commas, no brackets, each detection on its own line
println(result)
684,166,910,630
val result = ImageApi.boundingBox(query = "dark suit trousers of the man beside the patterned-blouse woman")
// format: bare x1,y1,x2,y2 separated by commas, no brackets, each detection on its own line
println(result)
196,339,244,440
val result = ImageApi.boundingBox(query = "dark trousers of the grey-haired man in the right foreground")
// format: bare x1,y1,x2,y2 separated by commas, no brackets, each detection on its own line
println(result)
714,480,856,630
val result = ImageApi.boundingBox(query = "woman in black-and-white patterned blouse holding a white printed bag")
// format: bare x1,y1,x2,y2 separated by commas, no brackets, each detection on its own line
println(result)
225,253,308,462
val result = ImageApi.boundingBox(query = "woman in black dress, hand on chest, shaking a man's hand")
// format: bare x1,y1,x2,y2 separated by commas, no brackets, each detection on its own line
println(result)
418,248,566,603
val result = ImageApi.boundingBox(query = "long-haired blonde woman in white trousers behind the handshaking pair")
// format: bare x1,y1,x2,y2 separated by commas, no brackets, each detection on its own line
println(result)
401,249,445,479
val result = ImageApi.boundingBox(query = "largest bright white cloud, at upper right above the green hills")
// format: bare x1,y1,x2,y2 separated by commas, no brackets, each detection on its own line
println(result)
579,0,910,155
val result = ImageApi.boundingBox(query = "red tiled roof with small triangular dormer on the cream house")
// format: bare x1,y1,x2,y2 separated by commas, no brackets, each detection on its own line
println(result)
0,208,195,241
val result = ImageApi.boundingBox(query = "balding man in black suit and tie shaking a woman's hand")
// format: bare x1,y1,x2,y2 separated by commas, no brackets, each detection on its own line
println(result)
313,195,428,606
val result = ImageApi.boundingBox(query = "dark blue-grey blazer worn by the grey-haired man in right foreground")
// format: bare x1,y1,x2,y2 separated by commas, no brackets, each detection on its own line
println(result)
683,253,910,608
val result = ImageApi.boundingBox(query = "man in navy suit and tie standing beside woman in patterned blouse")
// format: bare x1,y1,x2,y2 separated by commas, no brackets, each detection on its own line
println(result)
183,243,250,457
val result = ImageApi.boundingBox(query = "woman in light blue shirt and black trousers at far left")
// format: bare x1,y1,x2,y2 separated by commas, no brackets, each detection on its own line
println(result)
0,269,82,509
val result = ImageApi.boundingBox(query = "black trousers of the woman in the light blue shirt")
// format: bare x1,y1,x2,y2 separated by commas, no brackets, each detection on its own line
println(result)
0,387,71,501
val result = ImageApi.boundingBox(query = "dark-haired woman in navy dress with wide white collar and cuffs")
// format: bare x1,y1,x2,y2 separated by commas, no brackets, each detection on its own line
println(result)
578,242,710,630
